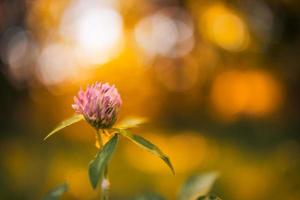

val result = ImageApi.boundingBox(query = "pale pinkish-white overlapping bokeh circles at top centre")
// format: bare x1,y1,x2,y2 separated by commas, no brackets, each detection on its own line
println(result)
134,8,194,57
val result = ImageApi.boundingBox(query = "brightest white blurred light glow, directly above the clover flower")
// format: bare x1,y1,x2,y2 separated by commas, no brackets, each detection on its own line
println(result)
60,0,123,65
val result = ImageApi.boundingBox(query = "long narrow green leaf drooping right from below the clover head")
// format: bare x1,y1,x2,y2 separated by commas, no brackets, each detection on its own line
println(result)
119,129,175,174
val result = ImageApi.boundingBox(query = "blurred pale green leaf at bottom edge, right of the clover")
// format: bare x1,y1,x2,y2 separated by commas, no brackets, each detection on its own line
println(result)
178,172,218,200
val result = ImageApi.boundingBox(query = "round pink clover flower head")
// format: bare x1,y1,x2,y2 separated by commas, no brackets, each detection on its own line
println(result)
72,82,122,130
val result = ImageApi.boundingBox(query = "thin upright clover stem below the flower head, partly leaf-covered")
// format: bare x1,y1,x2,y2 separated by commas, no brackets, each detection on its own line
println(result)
97,130,110,200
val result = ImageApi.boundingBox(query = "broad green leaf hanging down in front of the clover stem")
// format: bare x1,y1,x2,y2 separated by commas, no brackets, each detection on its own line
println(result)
89,134,118,189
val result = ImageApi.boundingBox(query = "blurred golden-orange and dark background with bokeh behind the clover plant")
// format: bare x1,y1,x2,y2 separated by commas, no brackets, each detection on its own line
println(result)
0,0,300,200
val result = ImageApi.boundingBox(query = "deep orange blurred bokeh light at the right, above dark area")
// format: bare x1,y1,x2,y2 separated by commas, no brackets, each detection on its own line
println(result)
211,70,282,118
